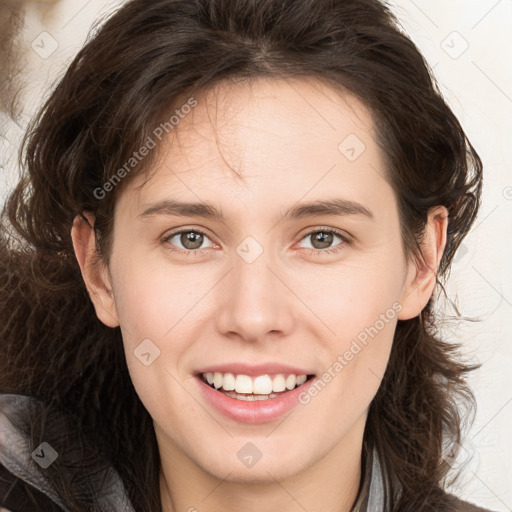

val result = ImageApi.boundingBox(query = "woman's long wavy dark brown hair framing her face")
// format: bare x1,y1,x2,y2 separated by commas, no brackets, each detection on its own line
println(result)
0,0,482,512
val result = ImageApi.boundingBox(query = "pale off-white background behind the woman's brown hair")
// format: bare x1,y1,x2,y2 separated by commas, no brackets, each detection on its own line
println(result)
0,0,512,512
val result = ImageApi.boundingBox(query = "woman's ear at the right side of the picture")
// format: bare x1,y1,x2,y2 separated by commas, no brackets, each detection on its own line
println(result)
398,206,448,320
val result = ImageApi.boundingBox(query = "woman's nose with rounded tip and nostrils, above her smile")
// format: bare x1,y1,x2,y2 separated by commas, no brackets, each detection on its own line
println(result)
217,245,297,342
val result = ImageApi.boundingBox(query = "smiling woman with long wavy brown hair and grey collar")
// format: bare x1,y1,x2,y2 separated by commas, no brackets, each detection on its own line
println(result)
0,0,492,512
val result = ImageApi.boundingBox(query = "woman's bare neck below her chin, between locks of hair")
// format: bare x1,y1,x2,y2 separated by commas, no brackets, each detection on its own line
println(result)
157,422,362,512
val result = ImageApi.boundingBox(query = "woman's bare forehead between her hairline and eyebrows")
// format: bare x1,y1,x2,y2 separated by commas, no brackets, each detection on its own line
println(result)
123,77,387,214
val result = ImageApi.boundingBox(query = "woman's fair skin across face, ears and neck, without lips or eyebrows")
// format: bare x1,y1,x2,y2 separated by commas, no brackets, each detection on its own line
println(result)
72,78,448,512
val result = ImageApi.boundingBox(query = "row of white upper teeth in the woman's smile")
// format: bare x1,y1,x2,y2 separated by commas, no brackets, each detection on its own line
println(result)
203,372,307,395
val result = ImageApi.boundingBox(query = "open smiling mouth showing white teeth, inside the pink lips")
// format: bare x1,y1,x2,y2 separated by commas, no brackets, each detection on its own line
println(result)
198,372,315,402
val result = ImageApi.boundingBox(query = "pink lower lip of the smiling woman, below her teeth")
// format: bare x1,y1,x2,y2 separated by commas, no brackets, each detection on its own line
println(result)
197,376,314,423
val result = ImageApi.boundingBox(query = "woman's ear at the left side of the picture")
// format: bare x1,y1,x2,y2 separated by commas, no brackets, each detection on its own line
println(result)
71,212,119,327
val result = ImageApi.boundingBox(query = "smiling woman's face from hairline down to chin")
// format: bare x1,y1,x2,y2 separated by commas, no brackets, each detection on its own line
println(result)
78,75,438,482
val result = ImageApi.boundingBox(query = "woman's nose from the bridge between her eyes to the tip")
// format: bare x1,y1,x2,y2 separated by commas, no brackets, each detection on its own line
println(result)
218,237,292,341
